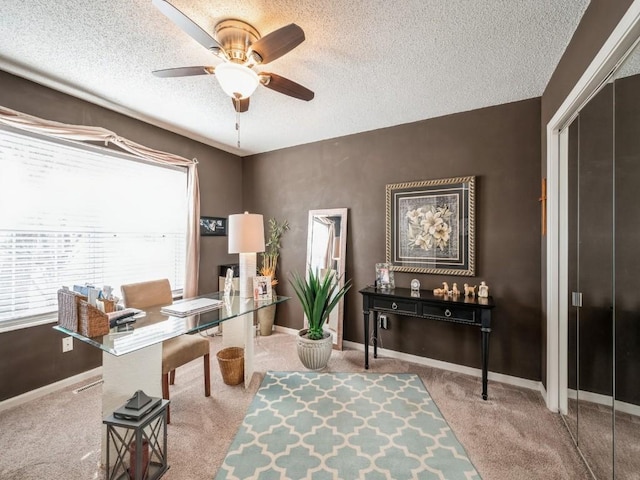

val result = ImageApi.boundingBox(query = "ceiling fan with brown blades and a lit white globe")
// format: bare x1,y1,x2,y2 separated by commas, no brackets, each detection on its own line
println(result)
152,0,314,113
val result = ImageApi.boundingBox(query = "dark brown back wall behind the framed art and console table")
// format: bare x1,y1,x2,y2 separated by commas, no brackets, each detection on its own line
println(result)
243,98,541,380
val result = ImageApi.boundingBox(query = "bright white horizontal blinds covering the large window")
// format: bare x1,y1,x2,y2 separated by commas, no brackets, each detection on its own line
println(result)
0,124,187,327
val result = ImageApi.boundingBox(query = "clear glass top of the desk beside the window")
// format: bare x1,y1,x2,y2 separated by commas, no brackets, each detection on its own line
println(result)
53,292,289,356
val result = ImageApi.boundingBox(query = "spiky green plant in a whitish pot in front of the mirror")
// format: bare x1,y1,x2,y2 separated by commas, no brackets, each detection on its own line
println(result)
289,269,351,370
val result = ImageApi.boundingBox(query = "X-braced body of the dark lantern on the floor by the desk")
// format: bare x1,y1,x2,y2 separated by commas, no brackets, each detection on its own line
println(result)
102,400,169,480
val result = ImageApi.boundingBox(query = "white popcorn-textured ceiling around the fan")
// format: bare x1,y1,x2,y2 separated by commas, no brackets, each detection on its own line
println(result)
0,0,589,156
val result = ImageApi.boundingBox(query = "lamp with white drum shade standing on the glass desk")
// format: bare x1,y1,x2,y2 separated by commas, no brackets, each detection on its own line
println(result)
229,212,264,298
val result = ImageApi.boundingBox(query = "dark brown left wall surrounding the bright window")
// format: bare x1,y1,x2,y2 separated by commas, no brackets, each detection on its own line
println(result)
0,71,242,401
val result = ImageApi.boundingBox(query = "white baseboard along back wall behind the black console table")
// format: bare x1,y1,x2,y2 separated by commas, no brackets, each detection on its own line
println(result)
275,325,545,398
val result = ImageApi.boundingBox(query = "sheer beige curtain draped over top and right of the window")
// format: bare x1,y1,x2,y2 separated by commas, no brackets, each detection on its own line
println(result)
0,106,200,297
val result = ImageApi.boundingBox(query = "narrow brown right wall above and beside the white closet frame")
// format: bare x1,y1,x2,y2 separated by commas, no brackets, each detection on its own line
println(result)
540,0,633,385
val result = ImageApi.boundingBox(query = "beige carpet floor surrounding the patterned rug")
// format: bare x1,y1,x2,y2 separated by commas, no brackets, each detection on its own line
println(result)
0,333,590,480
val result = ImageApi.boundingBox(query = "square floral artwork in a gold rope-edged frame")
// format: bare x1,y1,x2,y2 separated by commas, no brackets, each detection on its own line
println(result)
386,177,475,276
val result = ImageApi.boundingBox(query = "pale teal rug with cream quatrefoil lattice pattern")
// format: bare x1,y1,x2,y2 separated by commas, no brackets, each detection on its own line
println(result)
215,372,480,480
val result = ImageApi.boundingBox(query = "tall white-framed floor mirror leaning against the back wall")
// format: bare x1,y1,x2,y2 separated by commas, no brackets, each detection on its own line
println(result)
305,208,347,350
